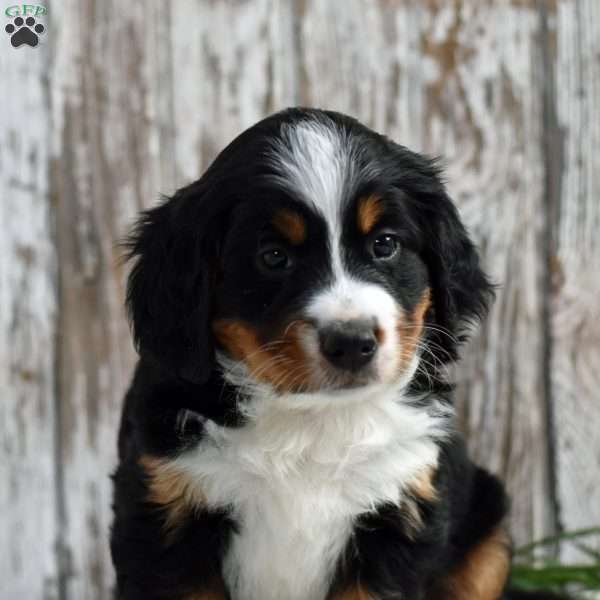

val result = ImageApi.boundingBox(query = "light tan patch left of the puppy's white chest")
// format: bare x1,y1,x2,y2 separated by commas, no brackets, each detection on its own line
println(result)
139,455,206,541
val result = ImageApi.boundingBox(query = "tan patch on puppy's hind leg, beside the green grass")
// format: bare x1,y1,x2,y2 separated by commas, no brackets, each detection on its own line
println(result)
439,528,510,600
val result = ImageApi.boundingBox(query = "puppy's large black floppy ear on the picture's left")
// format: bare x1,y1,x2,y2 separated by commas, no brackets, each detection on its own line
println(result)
127,188,214,383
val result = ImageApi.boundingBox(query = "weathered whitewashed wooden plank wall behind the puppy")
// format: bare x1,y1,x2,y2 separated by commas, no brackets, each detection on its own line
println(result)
0,0,600,600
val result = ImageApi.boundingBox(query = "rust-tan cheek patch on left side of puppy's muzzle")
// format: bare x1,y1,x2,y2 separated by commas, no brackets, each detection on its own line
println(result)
213,319,312,392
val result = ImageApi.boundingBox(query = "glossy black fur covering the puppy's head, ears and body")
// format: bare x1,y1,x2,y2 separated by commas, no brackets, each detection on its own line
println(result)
111,109,556,600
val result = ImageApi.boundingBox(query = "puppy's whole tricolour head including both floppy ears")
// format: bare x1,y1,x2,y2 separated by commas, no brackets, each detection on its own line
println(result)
128,109,490,392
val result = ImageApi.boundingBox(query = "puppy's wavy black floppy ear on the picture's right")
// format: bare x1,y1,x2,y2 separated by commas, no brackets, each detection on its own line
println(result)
425,191,494,358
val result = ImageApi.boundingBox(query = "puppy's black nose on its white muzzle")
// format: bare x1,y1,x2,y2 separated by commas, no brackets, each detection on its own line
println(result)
319,321,377,370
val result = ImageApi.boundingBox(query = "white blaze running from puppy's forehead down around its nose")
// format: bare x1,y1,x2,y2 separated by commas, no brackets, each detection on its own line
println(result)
271,119,402,382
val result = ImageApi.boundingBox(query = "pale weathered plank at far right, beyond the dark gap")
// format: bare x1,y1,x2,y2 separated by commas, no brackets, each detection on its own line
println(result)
549,0,600,560
